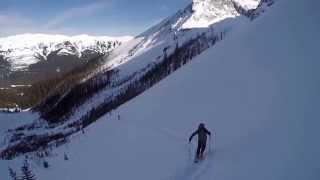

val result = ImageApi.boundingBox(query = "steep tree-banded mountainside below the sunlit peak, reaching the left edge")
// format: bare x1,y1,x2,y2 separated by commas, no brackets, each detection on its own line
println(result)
0,0,276,159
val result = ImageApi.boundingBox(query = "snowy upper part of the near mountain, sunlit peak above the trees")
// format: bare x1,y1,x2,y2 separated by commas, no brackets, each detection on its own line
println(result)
92,0,273,79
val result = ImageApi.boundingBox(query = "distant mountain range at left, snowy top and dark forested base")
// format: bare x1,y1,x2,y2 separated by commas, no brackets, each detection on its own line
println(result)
0,34,132,110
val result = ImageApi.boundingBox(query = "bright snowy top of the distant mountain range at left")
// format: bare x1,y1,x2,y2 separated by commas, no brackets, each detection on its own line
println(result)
0,34,131,71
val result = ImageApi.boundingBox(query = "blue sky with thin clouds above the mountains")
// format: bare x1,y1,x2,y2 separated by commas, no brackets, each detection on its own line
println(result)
0,0,191,37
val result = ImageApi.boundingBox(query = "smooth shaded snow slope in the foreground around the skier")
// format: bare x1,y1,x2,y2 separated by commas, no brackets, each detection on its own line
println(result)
0,0,320,180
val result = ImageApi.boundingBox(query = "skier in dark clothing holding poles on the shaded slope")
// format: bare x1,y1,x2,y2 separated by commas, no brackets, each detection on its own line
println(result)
189,123,211,162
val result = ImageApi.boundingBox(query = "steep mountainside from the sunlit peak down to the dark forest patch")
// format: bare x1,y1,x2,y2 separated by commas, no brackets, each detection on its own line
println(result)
37,0,268,125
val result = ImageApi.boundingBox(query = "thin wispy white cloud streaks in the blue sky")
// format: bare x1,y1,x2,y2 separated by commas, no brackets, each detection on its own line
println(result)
0,0,110,37
